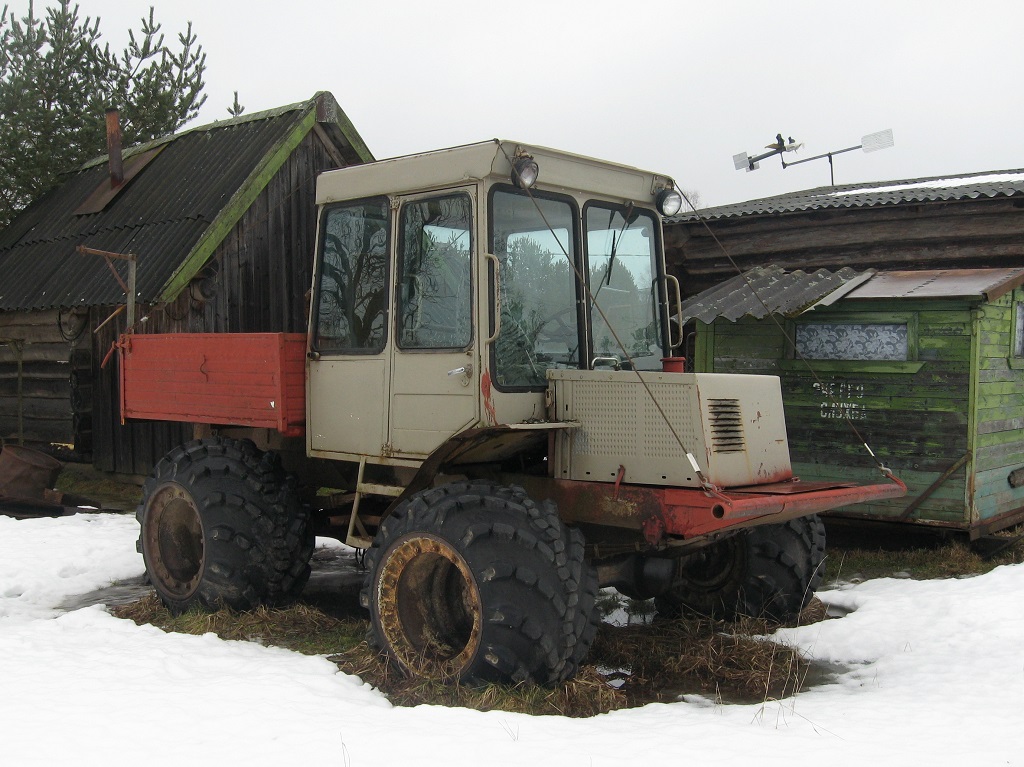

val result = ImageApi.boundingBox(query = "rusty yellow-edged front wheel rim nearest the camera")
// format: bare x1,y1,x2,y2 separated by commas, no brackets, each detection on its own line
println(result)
378,534,481,679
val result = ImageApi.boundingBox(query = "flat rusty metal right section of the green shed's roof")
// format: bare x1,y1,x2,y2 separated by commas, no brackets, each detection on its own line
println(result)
847,269,1024,301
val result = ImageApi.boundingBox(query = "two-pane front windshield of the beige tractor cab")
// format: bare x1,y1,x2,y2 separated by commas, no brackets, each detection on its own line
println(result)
489,186,664,390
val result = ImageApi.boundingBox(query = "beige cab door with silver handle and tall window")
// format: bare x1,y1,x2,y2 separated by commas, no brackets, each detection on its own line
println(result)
388,187,479,458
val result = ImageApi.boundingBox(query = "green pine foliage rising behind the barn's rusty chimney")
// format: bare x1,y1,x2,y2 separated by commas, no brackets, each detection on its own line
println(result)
0,0,206,228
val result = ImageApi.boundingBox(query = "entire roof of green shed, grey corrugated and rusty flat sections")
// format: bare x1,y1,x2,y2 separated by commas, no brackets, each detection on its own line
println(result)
682,266,1024,325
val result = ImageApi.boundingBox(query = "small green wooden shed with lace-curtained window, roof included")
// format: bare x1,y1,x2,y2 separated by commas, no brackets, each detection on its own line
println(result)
682,267,1024,538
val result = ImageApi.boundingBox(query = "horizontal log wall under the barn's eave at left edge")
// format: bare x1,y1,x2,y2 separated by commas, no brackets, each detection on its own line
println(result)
0,309,92,454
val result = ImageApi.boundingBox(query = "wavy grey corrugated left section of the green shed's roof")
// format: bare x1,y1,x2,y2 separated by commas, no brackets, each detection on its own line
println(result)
682,266,871,324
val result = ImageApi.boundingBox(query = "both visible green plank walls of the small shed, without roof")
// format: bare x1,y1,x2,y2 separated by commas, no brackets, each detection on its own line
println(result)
695,291,1024,526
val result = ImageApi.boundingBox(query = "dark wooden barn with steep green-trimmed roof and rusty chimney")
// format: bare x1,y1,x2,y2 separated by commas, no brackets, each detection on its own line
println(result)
0,92,373,474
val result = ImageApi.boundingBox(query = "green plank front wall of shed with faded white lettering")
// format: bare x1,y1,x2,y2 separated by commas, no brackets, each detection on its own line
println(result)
696,302,972,526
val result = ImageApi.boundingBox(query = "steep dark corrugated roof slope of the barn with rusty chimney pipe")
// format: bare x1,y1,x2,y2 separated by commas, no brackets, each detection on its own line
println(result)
0,94,368,310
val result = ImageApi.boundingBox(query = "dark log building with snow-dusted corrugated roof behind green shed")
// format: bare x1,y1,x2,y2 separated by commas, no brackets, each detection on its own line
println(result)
665,170,1024,296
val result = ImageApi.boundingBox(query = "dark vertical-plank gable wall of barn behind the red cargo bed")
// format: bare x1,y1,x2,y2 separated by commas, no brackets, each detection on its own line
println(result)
93,132,338,474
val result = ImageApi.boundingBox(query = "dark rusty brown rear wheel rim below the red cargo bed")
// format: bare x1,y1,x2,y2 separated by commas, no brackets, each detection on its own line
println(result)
142,482,204,599
